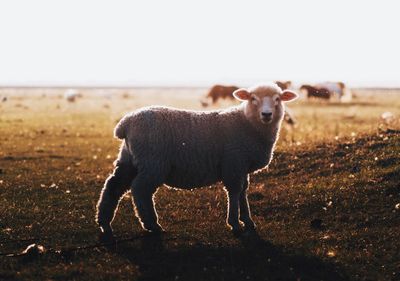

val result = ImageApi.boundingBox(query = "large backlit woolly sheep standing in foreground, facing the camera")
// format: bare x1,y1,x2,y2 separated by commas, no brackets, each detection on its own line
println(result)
96,83,298,241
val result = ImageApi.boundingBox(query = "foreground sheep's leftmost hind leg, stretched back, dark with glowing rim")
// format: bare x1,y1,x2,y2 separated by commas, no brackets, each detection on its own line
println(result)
96,162,137,242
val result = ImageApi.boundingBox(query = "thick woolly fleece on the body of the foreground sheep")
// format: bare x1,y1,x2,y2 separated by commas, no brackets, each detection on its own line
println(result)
115,103,282,189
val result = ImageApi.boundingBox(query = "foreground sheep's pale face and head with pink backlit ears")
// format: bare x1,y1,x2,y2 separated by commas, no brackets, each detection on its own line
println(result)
233,83,298,124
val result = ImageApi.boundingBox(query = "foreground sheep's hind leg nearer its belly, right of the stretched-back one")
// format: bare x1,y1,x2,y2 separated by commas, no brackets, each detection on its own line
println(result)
131,175,164,233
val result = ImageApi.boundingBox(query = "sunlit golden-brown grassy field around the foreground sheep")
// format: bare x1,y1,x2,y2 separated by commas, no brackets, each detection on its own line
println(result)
0,86,400,280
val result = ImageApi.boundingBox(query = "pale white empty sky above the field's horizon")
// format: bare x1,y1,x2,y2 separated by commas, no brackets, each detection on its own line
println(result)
0,0,400,86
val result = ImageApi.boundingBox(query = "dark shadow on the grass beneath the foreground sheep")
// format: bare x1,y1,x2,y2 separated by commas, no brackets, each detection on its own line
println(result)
116,234,348,281
